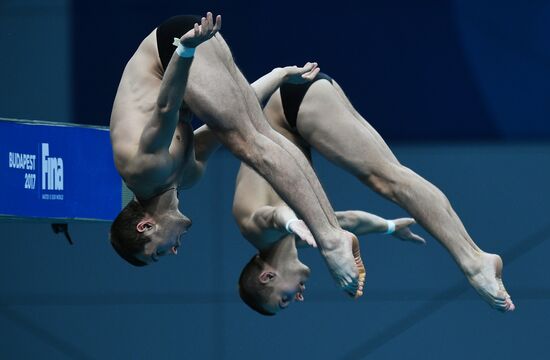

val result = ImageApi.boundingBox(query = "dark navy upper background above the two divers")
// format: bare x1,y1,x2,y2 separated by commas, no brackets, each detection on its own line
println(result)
72,0,550,140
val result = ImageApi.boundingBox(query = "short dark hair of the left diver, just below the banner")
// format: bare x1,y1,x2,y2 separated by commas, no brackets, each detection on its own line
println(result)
109,199,151,266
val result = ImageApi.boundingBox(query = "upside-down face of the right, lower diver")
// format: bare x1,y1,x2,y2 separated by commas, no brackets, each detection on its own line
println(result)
263,264,310,314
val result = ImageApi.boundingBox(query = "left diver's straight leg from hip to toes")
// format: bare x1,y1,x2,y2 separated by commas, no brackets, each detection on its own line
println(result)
184,35,362,294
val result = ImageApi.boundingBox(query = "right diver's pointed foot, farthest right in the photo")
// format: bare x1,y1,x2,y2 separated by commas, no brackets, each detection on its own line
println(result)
464,253,516,312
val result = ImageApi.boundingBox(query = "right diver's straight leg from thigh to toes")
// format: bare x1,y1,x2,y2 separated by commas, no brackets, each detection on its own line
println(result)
297,81,513,310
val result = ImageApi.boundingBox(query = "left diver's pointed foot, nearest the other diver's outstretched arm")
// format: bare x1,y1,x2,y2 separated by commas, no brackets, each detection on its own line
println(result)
322,231,366,298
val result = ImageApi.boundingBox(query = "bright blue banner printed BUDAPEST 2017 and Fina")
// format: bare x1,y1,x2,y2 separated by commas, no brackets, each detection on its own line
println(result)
0,119,122,221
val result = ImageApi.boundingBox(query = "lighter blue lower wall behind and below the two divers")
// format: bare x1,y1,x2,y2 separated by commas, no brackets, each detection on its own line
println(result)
0,145,550,360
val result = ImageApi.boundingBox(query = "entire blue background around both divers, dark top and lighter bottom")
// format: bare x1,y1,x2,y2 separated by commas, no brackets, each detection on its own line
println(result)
0,0,550,359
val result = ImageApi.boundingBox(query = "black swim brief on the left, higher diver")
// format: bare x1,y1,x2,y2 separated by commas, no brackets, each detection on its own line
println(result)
157,15,201,70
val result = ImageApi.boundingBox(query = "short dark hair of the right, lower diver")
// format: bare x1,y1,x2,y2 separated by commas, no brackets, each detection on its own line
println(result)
239,254,275,316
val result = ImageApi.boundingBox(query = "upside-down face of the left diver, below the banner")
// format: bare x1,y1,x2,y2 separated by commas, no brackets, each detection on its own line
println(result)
138,213,191,264
